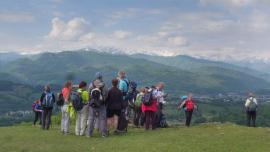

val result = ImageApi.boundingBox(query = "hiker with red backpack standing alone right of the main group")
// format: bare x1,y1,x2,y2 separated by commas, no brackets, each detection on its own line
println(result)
178,93,197,127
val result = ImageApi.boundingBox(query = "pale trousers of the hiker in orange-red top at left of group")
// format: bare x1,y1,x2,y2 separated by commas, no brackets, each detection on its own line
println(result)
61,104,70,134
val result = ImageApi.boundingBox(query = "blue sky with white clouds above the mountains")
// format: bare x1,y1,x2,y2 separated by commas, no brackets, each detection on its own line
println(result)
0,0,270,60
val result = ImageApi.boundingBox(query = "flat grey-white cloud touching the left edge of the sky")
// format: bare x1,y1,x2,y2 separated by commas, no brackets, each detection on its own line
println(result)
0,12,35,23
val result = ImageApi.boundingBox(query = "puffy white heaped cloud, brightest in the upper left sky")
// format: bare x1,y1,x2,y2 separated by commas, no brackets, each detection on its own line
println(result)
46,17,89,40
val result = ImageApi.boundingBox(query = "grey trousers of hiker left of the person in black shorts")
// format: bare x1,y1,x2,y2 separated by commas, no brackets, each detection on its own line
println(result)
86,105,107,137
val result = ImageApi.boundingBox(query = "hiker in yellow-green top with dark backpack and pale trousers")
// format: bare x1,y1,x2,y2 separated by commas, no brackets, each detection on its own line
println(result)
73,81,89,136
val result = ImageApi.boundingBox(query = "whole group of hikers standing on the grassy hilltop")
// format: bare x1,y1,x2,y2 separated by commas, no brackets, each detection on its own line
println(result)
32,71,258,137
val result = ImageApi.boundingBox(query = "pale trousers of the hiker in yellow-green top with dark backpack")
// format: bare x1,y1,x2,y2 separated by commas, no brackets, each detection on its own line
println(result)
75,104,89,136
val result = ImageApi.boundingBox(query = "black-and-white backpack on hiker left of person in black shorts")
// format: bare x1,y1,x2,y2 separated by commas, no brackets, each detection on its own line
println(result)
90,88,104,108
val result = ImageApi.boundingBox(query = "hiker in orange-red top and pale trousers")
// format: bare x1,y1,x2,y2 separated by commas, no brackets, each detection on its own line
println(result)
60,81,72,135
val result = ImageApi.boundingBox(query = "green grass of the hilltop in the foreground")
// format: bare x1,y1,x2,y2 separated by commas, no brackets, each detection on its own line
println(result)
0,124,270,152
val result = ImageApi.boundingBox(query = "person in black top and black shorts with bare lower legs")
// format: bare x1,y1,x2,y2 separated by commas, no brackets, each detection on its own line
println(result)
106,79,123,133
